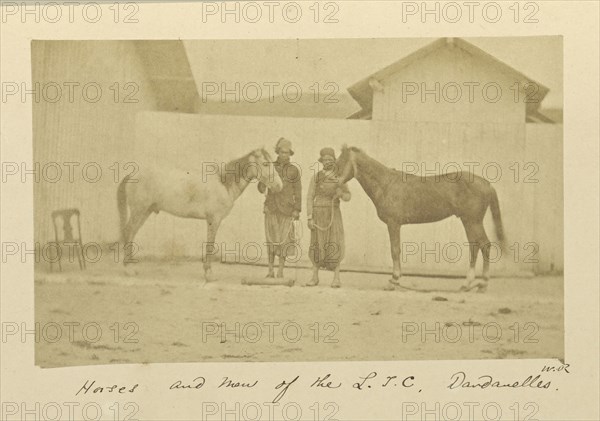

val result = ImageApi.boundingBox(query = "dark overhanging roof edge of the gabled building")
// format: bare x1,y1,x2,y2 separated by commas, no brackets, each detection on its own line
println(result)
348,38,549,118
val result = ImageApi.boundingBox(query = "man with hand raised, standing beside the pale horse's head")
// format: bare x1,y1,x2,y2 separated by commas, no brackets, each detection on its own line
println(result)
258,137,302,278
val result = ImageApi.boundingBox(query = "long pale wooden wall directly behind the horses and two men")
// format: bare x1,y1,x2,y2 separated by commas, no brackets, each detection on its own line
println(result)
130,112,563,274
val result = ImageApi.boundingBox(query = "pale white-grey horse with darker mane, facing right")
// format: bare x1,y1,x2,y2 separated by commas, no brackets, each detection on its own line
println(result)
117,149,283,282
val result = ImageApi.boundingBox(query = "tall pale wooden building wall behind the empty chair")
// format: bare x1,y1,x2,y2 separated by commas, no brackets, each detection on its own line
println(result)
32,41,155,244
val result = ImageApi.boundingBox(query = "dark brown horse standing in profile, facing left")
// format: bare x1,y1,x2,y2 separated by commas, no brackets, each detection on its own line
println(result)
337,146,504,292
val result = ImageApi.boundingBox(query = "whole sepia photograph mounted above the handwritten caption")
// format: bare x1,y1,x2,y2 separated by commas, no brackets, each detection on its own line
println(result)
30,36,564,368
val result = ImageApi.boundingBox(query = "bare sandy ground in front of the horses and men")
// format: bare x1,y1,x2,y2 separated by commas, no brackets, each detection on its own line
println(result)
35,262,564,367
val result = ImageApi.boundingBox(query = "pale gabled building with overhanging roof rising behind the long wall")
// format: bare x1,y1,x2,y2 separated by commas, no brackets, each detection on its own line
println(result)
348,38,552,123
